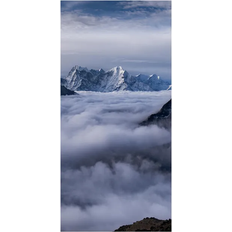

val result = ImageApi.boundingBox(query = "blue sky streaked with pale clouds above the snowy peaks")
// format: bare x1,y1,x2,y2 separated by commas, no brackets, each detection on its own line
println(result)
60,1,171,79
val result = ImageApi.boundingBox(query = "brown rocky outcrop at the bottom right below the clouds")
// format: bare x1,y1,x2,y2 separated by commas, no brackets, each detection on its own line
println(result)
115,217,171,231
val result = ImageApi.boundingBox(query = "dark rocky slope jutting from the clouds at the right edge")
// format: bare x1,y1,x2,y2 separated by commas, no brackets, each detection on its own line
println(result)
140,99,171,129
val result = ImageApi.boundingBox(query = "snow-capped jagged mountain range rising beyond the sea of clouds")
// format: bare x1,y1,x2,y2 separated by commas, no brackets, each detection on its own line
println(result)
61,65,171,92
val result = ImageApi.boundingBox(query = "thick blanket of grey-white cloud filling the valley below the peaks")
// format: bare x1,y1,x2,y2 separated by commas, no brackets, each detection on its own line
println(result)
61,91,171,230
